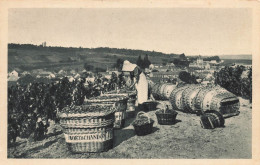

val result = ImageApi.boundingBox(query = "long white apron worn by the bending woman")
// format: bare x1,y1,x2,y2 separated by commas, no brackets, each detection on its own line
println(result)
135,73,148,104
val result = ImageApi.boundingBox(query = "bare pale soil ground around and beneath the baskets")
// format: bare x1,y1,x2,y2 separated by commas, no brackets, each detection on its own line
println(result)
8,99,252,159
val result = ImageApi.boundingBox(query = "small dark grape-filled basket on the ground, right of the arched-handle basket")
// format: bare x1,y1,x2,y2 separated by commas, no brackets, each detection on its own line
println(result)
155,109,178,125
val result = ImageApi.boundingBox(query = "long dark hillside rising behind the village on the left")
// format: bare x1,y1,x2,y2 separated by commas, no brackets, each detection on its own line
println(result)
8,44,178,71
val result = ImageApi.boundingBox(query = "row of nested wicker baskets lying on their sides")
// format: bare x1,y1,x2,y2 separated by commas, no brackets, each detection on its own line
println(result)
152,83,240,117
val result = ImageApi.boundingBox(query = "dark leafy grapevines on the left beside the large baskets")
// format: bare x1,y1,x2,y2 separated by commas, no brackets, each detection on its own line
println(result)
8,75,123,144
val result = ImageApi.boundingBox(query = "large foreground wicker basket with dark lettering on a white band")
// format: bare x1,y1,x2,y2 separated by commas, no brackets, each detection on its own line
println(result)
58,105,116,153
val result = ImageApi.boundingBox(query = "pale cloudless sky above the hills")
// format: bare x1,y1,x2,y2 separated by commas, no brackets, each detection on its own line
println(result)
8,8,252,55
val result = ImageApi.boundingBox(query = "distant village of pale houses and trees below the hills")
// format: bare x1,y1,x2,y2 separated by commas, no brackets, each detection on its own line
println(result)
8,56,251,85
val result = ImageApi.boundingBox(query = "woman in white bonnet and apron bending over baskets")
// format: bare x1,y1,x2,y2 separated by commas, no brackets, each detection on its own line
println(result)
122,60,148,110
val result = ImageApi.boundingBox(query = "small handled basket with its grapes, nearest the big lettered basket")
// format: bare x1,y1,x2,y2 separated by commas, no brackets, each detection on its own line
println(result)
132,111,154,136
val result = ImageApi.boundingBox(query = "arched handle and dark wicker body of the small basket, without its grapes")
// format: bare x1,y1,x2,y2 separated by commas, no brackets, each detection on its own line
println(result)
132,111,154,136
